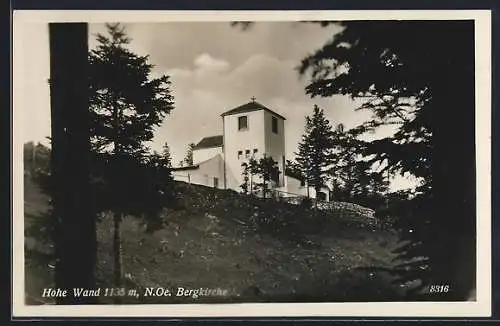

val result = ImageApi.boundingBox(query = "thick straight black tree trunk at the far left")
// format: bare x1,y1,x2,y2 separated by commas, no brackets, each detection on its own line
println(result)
49,23,97,304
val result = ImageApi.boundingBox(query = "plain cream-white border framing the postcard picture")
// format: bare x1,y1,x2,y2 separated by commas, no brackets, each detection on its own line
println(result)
12,10,492,317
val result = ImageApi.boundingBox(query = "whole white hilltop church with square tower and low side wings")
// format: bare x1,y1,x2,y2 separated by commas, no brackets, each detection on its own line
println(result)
173,98,329,201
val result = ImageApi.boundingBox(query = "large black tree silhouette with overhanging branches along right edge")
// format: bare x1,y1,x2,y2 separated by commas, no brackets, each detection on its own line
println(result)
300,21,476,300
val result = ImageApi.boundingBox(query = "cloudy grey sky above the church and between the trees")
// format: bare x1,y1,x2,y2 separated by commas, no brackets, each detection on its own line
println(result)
14,22,413,190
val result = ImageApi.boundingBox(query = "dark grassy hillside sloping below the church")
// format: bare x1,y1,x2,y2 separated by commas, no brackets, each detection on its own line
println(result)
25,178,401,304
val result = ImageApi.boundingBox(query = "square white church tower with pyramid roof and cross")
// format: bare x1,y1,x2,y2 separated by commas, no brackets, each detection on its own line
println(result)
221,98,286,189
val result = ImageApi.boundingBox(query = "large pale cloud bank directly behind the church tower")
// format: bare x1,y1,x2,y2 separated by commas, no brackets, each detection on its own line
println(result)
151,54,372,166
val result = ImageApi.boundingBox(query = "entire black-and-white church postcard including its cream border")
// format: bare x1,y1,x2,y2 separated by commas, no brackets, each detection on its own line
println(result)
13,11,491,316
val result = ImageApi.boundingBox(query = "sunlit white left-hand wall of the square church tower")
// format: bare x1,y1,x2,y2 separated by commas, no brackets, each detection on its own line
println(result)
223,110,265,189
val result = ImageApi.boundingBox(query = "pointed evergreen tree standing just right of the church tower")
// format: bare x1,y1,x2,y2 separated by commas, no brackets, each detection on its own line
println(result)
295,105,334,199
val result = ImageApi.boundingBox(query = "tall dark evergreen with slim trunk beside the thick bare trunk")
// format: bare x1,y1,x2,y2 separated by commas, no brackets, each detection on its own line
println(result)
89,24,173,292
